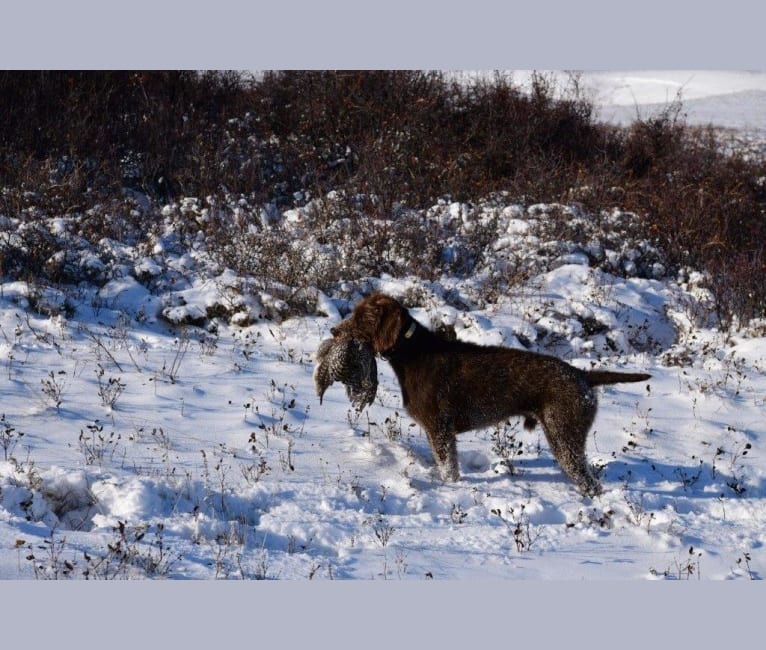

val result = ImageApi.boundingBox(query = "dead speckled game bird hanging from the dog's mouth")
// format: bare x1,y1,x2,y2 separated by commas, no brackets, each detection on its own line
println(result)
314,336,378,411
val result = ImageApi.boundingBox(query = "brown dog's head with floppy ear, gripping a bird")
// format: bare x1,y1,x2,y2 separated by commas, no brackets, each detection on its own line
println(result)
332,293,411,354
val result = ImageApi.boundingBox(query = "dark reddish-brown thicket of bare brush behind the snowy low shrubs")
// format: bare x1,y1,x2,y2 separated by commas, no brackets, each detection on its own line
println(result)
0,71,766,321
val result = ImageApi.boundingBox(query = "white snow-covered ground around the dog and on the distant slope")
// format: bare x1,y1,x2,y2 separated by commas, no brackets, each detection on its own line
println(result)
0,73,766,580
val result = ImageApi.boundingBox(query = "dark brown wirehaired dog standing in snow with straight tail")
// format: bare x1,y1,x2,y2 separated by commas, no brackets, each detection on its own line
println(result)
332,293,651,496
